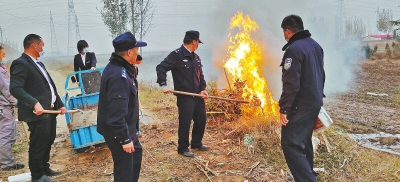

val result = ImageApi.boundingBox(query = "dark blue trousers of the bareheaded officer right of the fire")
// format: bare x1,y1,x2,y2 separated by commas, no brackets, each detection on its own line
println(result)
281,108,320,182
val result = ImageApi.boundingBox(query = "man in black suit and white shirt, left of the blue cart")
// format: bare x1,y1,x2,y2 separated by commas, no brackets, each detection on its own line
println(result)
10,34,66,182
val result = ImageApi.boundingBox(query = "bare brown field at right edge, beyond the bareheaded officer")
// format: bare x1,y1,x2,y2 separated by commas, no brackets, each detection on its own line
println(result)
324,60,400,134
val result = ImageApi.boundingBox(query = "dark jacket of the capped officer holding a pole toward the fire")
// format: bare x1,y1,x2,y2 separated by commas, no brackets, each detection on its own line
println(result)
156,45,206,93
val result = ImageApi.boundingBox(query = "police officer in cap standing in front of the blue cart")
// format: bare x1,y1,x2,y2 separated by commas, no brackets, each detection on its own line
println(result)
97,32,147,182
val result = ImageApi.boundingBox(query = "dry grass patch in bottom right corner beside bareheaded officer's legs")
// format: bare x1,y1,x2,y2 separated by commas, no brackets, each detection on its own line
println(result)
315,126,400,181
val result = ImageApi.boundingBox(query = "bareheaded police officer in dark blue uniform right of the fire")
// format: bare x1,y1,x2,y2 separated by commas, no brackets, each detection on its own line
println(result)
279,15,325,182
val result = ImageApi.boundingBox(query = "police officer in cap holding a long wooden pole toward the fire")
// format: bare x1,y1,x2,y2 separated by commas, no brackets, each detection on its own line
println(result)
156,30,210,157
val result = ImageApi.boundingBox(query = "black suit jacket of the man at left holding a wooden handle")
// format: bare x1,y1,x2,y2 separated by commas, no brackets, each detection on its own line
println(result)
10,53,64,122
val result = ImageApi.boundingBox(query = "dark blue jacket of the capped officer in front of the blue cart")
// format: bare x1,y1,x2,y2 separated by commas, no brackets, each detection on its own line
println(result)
97,53,139,145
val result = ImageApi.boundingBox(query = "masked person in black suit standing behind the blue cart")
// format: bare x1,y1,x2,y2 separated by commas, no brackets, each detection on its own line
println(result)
74,40,97,82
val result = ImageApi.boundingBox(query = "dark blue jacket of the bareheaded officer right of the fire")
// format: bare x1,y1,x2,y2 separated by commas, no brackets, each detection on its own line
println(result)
279,30,325,114
